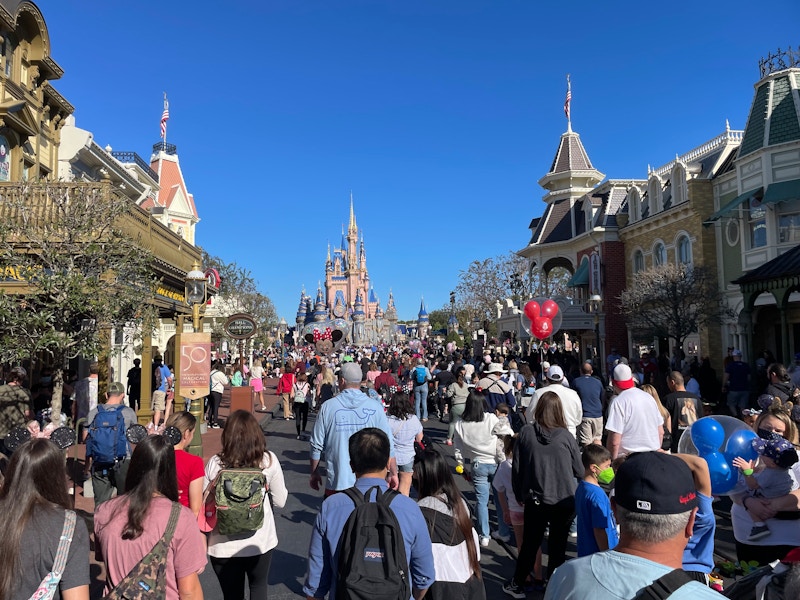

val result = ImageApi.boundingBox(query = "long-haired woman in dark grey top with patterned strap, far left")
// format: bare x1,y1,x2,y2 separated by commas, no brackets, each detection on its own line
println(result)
0,438,90,600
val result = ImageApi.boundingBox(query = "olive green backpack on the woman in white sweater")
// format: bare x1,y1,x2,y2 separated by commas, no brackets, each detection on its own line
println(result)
214,468,267,535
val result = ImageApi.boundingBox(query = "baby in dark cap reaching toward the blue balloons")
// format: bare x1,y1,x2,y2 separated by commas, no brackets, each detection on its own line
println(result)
733,437,798,542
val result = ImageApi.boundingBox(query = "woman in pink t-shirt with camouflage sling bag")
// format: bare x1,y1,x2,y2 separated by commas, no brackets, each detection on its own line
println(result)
94,435,208,600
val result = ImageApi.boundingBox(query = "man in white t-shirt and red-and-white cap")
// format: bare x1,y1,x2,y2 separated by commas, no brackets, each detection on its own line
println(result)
606,364,664,459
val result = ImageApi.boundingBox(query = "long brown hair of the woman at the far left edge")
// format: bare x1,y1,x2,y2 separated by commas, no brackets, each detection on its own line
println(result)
0,438,71,600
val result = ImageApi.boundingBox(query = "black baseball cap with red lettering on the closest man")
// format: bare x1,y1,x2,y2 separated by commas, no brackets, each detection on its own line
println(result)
614,452,697,515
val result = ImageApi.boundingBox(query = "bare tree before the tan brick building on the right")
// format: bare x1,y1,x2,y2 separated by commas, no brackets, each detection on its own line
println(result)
620,264,731,347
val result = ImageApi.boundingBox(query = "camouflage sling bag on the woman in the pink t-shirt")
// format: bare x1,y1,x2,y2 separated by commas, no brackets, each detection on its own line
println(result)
103,502,181,600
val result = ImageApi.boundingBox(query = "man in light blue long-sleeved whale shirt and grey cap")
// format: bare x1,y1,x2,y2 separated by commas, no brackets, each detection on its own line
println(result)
309,362,398,496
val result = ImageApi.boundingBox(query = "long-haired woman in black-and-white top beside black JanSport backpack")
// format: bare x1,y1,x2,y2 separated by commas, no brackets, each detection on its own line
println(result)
414,448,486,600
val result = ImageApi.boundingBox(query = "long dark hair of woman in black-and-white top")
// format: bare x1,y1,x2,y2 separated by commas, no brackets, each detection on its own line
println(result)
414,448,481,579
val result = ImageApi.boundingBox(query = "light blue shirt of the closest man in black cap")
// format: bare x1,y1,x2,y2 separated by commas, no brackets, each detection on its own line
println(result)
544,550,721,600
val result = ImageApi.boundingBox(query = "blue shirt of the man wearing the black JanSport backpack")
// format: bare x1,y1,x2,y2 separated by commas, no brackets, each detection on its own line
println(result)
303,476,436,600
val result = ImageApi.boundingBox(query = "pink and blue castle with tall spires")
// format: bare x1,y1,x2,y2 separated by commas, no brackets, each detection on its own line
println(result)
296,194,397,345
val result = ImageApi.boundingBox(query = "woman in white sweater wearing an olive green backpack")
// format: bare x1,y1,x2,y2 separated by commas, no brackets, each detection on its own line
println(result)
203,410,288,600
